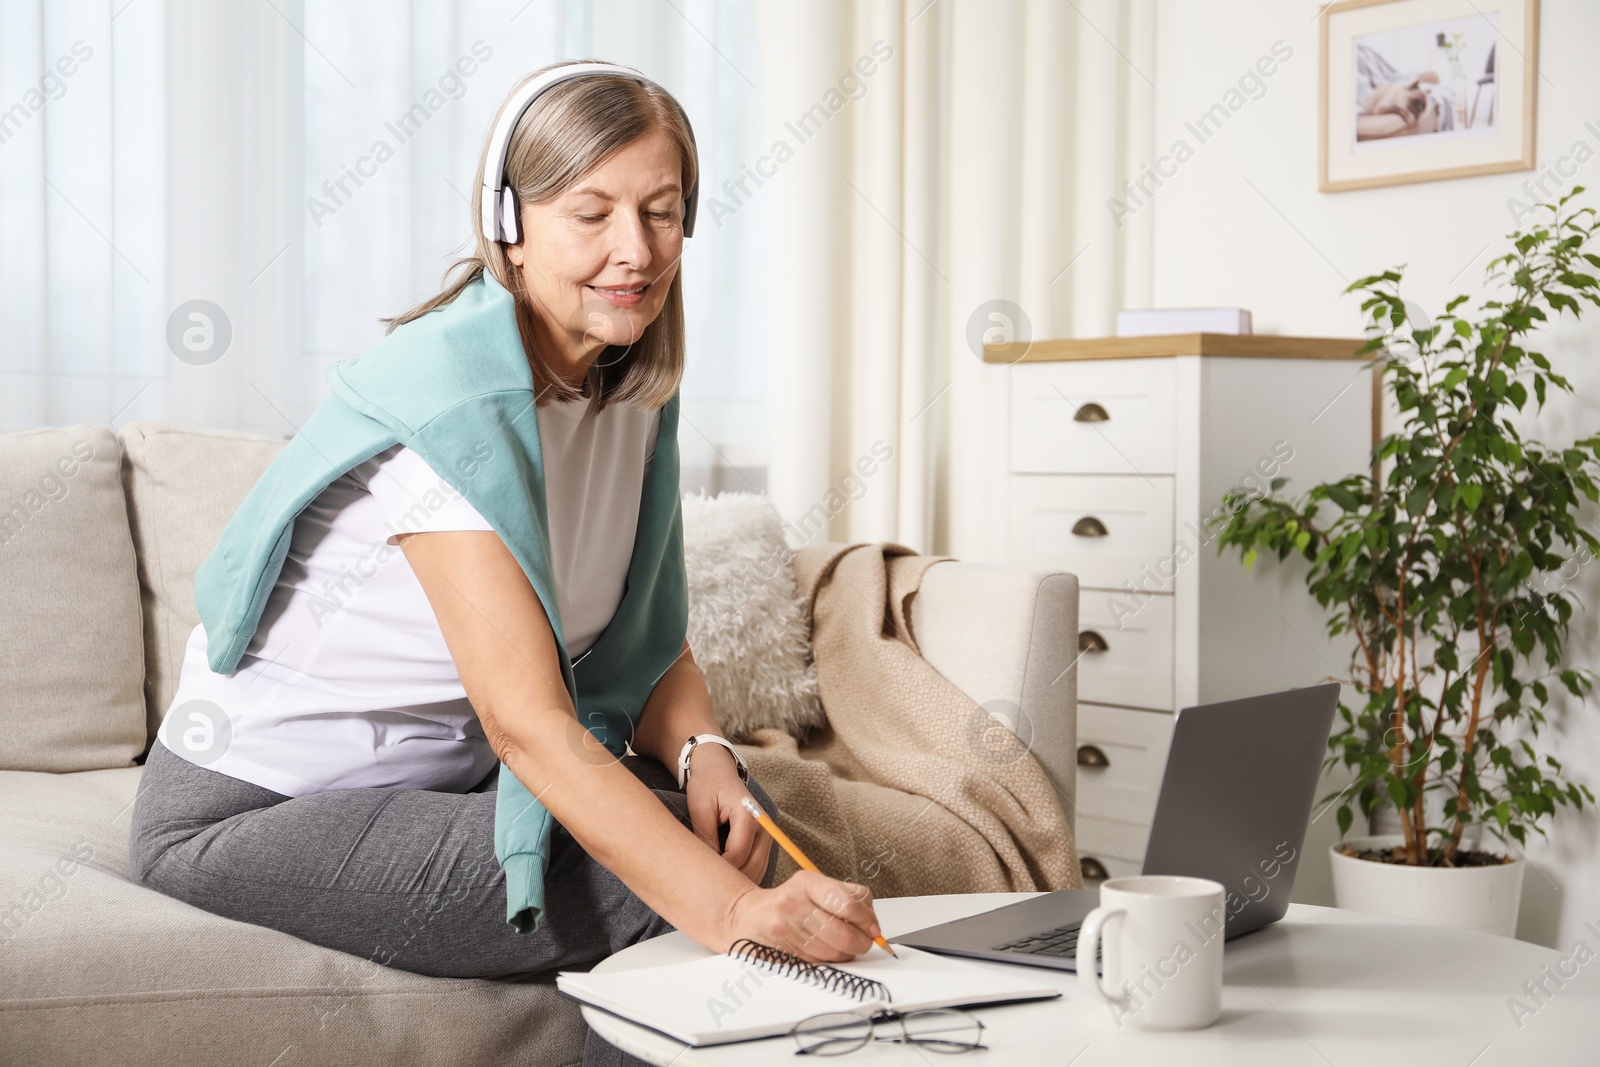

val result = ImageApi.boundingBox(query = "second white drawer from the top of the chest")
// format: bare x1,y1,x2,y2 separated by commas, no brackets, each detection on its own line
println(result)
1006,474,1173,592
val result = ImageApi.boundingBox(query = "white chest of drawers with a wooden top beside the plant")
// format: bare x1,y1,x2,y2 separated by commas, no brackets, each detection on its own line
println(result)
986,334,1373,877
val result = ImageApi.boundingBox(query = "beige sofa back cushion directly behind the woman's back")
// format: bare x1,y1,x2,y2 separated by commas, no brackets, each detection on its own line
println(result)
118,422,285,737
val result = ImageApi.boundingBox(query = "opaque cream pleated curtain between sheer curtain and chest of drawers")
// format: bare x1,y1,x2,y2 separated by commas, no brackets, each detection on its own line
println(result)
762,0,1154,558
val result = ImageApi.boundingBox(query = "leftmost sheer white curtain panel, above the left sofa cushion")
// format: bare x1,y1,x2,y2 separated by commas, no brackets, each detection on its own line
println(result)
0,0,170,432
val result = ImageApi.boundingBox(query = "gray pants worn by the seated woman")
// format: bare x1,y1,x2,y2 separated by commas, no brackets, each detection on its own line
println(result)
128,741,778,1064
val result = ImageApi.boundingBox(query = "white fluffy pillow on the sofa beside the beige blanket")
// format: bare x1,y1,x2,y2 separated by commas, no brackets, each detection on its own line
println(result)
683,493,826,741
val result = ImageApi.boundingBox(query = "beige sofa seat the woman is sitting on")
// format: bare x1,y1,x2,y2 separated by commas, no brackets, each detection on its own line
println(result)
0,766,586,1067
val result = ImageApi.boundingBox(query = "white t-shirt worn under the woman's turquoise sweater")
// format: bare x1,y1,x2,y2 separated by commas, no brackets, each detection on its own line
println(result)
158,388,661,797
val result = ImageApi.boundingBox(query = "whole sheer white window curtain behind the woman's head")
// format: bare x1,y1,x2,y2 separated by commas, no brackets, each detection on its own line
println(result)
0,0,766,490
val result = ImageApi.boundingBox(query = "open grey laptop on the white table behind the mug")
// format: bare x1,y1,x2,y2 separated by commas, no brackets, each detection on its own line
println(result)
890,683,1339,971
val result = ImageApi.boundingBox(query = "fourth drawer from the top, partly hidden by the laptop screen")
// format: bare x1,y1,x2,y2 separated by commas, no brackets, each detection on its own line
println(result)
1077,704,1173,831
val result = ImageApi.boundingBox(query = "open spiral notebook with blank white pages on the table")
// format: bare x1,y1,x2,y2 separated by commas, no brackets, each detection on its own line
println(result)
555,941,1061,1046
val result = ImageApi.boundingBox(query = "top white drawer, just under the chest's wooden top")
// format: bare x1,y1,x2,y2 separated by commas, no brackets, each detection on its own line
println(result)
1011,360,1178,475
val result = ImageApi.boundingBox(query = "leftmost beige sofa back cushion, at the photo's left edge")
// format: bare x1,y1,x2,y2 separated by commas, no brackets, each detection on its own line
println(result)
0,426,146,771
